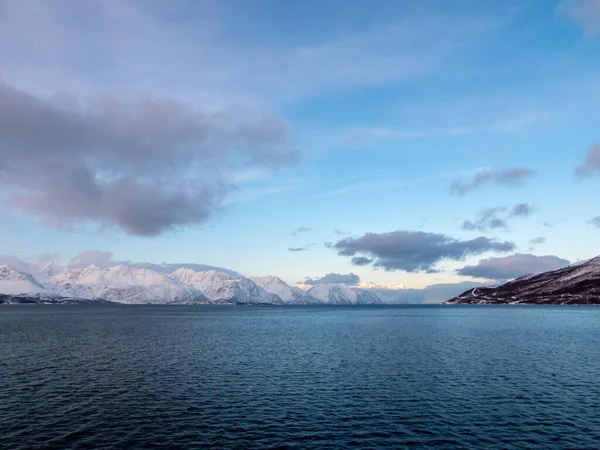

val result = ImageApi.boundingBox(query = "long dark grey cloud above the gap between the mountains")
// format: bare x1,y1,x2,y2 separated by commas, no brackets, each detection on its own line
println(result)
328,230,515,272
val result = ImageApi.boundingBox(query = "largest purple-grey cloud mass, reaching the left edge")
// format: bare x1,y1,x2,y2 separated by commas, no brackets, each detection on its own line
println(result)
0,81,298,236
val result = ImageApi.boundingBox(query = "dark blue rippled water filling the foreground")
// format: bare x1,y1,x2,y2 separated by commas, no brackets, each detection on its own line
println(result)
0,305,600,449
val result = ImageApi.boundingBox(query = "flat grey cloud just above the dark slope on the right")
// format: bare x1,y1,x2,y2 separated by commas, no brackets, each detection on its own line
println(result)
457,253,570,280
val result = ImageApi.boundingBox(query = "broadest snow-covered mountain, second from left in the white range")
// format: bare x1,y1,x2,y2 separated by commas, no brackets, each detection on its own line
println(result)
49,265,207,304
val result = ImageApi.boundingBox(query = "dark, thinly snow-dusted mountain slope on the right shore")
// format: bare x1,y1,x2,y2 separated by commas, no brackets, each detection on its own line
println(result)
446,257,600,305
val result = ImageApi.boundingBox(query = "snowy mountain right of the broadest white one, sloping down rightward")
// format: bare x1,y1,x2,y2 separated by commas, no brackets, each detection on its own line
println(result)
171,268,283,305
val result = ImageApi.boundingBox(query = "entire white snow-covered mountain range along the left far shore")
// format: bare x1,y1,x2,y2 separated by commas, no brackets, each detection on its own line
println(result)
0,263,392,305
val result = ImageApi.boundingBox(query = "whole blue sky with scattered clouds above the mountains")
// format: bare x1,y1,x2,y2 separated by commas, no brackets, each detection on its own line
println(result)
0,0,600,289
